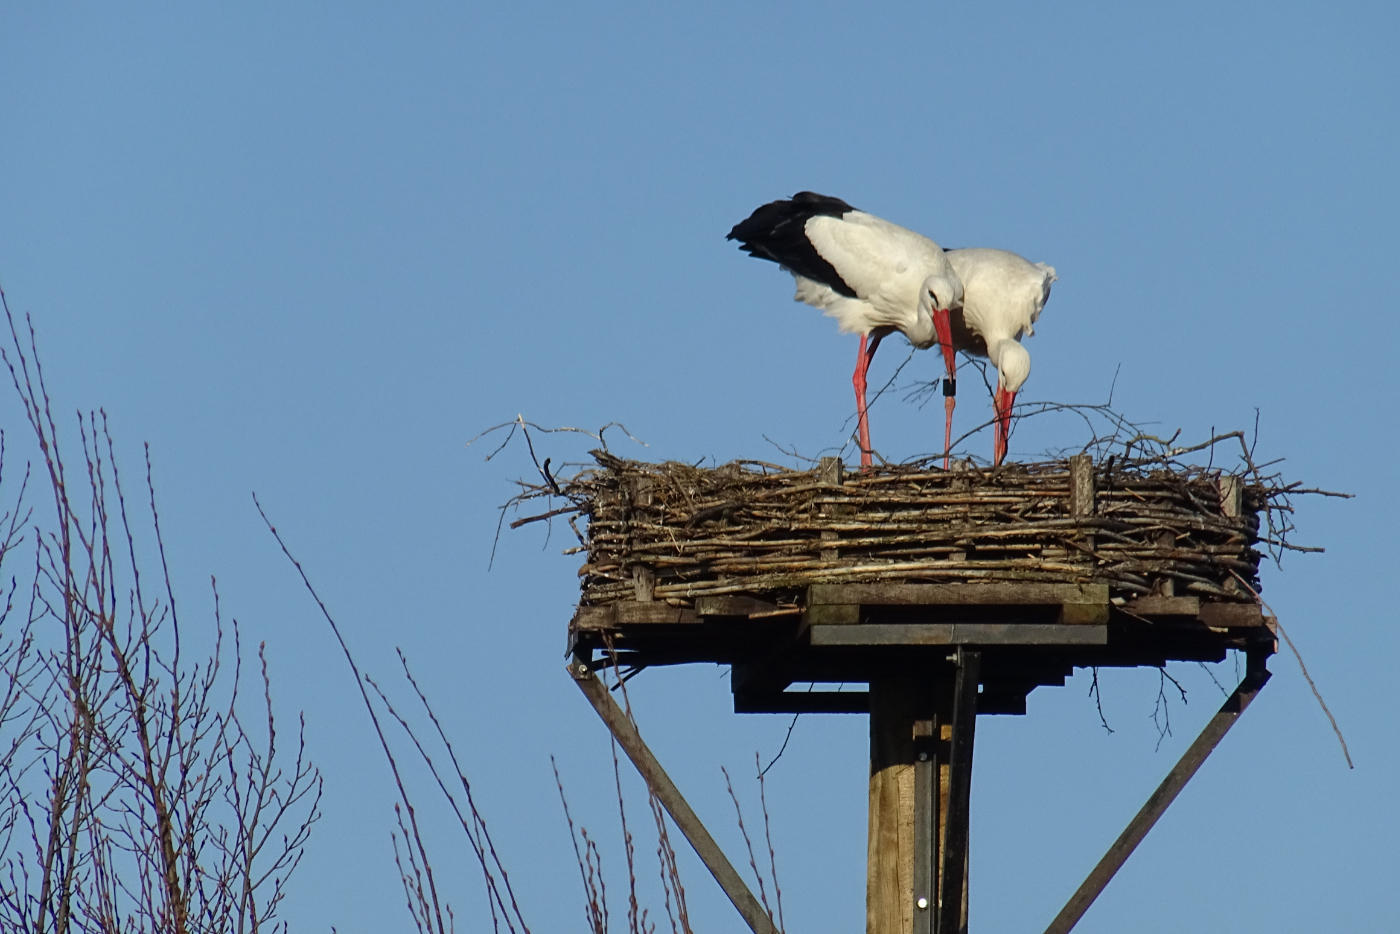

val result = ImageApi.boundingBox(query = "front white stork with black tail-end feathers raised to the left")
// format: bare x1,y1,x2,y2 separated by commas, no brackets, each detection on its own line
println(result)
728,192,968,466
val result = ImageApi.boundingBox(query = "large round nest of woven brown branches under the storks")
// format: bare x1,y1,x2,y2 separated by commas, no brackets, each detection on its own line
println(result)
510,433,1323,606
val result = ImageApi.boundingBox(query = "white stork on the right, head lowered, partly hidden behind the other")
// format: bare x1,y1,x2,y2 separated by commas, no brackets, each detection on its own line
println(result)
944,246,1057,466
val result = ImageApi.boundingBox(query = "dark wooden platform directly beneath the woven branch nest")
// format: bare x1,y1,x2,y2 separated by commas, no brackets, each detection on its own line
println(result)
568,584,1275,714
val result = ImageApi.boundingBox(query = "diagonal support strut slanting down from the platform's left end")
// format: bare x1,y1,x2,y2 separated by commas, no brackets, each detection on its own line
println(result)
568,661,777,934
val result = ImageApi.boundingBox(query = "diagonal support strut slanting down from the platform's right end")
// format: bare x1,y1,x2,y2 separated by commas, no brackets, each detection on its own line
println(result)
1046,653,1270,934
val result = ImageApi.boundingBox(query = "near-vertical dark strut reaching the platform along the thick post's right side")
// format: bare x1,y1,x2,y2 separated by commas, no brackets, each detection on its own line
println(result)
937,648,981,934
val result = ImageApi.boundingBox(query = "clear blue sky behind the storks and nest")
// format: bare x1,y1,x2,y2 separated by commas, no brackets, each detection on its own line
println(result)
0,3,1400,934
